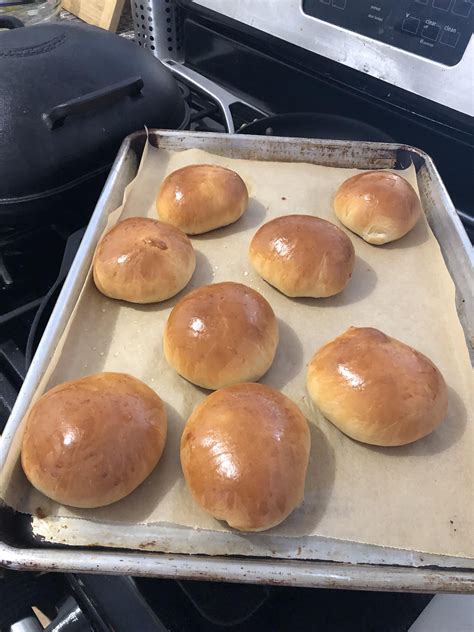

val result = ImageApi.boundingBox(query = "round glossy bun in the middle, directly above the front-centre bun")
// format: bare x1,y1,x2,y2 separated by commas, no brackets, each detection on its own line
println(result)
163,282,278,390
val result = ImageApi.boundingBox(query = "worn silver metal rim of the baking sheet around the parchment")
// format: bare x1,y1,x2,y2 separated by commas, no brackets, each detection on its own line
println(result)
0,131,474,592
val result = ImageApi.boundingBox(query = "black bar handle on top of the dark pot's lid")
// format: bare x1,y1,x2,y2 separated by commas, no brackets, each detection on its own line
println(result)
43,77,144,130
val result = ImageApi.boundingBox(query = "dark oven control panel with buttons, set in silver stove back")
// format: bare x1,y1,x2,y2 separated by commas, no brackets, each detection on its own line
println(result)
303,0,474,66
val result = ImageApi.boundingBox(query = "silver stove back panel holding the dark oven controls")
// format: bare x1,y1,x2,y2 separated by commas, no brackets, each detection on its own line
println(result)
186,0,474,117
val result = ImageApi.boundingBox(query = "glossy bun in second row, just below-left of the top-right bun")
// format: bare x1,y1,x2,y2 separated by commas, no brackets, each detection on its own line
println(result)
249,215,355,298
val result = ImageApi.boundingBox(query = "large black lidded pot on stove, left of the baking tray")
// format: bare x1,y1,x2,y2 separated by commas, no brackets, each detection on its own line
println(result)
0,18,189,225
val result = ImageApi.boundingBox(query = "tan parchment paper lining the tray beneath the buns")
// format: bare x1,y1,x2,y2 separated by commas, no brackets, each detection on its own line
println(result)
1,142,474,558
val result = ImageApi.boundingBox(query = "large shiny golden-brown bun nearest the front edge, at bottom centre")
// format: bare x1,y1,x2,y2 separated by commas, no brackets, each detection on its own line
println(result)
181,384,311,531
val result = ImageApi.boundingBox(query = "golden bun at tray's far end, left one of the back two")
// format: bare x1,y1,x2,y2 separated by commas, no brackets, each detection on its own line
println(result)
156,165,248,235
